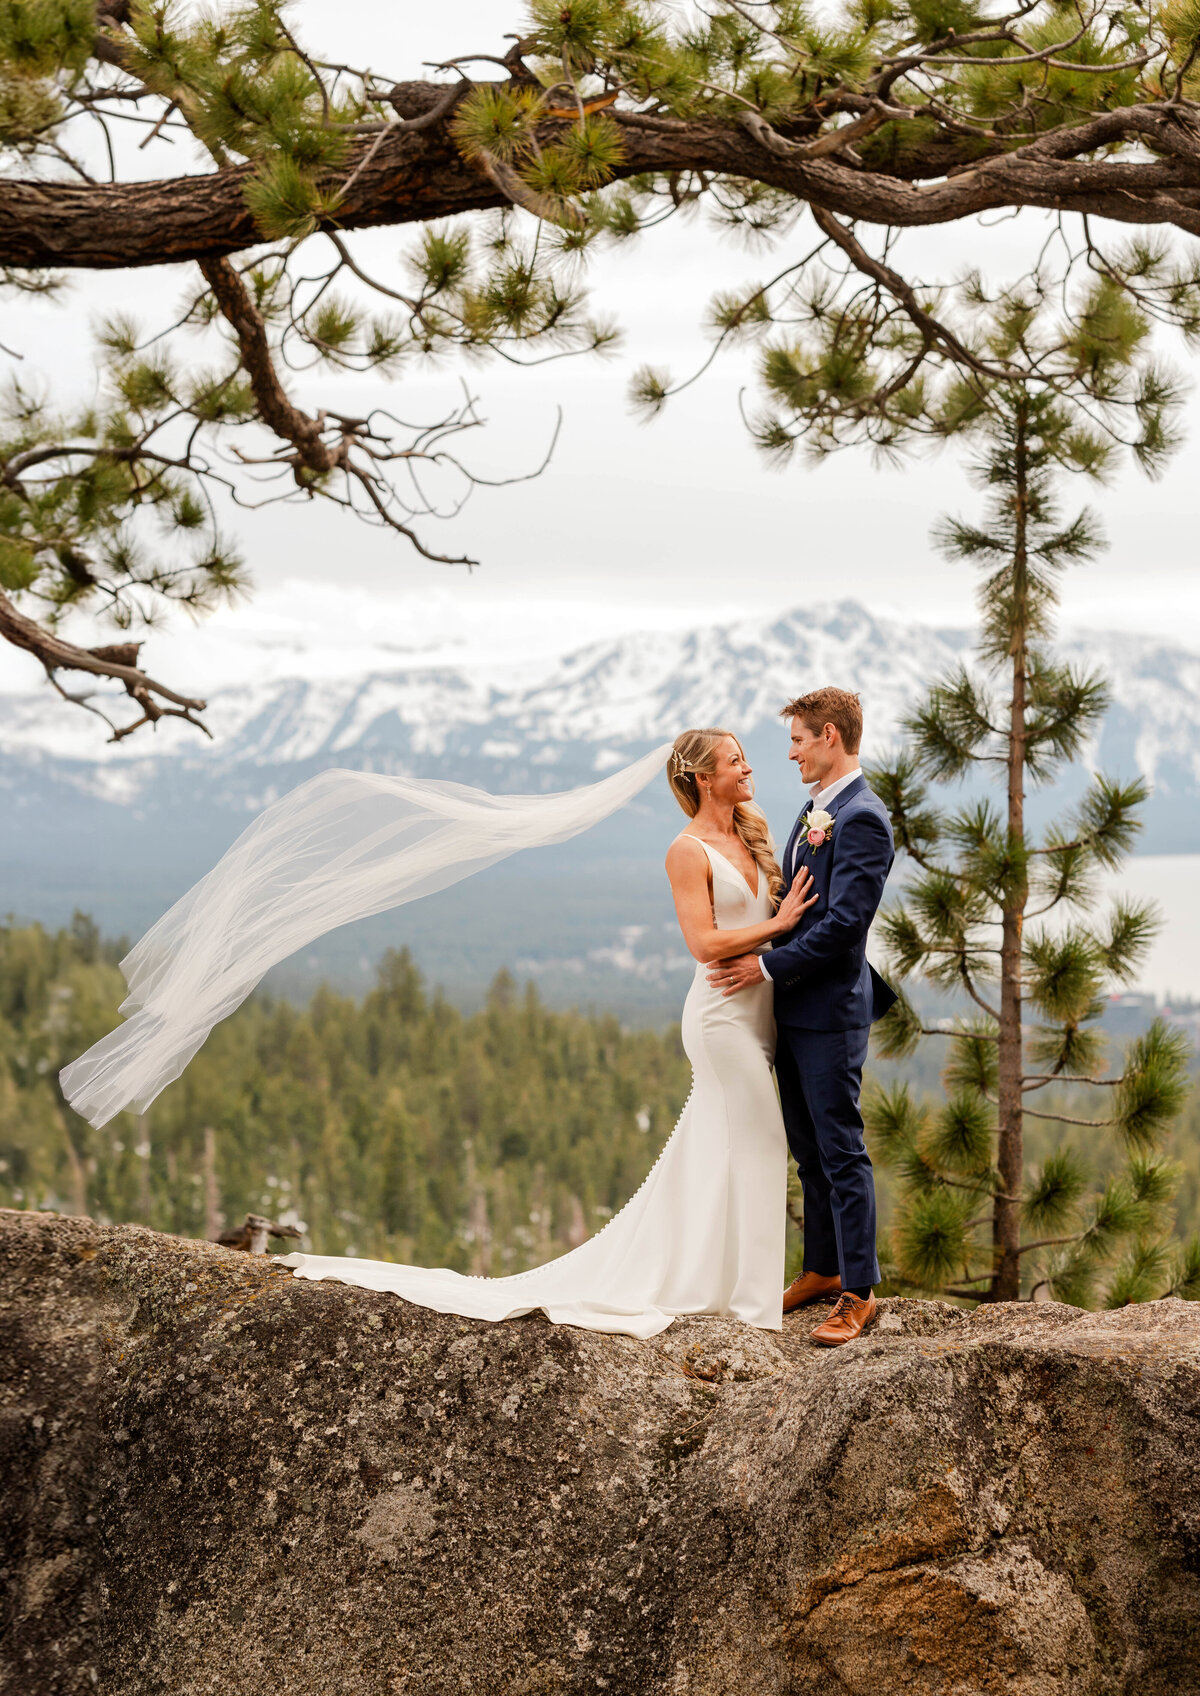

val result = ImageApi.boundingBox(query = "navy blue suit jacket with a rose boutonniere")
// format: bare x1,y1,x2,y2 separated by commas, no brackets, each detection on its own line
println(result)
763,777,897,1031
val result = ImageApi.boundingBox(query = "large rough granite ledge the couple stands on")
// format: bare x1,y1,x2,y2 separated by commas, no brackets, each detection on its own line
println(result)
0,1214,1200,1696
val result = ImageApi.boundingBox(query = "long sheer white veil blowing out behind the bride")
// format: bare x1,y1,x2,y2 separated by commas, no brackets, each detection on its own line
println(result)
59,745,669,1126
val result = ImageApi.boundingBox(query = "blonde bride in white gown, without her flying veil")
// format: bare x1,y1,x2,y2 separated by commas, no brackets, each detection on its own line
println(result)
283,729,815,1336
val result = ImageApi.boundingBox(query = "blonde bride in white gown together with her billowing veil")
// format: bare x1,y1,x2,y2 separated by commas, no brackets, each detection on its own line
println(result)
61,729,815,1336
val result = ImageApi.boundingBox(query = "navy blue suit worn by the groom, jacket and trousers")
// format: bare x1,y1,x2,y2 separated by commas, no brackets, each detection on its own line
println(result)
763,777,897,1289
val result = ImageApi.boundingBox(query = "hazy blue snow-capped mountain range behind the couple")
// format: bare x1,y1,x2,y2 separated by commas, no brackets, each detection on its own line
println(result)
0,600,1200,1014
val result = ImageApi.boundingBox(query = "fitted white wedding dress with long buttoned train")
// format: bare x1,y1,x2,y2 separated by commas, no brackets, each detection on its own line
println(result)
281,838,788,1336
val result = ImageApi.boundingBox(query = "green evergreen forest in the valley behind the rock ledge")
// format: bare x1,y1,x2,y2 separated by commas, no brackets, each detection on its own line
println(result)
0,916,1200,1295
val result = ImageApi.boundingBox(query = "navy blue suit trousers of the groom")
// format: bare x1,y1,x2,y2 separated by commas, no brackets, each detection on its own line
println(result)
775,1024,880,1289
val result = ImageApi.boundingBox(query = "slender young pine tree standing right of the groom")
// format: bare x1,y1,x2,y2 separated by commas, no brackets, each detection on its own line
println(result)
868,280,1200,1304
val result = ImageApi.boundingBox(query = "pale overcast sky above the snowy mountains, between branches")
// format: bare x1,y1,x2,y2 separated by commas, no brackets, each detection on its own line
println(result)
0,0,1200,689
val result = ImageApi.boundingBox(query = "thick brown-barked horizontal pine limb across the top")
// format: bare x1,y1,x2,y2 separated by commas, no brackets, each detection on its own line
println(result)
0,103,1200,270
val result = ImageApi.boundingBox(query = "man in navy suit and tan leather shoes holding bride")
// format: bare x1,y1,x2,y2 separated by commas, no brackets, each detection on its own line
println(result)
708,689,897,1347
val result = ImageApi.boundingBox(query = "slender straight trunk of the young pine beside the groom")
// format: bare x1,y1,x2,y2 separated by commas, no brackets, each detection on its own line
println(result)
992,413,1029,1301
